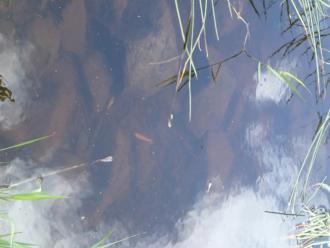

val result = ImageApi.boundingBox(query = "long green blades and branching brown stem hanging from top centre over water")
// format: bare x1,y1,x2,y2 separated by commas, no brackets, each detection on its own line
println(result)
170,0,310,121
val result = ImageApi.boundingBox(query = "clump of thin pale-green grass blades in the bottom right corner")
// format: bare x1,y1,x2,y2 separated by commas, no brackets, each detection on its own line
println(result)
288,109,330,248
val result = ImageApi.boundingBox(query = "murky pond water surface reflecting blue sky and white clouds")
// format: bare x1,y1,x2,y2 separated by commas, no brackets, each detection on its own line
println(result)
0,0,326,247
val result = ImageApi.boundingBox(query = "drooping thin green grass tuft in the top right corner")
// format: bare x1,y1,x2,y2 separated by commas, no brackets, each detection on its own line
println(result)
272,0,330,97
